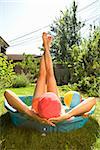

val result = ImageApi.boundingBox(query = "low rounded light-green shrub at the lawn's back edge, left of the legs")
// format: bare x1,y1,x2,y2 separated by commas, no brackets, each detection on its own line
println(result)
12,74,29,88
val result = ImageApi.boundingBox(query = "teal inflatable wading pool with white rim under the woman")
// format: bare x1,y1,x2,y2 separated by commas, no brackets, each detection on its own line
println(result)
5,96,95,132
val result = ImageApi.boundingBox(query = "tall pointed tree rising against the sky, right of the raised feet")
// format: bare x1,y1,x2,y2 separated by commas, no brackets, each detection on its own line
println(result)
51,1,84,63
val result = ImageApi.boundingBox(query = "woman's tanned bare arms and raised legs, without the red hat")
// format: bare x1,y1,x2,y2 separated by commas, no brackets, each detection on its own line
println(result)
4,32,96,126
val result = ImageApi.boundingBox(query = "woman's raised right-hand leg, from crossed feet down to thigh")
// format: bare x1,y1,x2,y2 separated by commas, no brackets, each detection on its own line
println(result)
42,33,58,95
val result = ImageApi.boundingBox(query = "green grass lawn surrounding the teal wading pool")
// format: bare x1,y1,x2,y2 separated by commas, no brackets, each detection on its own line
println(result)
0,86,100,150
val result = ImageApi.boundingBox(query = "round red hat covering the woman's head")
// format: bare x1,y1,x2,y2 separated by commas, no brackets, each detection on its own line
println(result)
38,92,61,119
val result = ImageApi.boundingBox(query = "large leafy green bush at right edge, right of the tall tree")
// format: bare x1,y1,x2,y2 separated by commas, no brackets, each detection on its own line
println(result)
69,27,100,96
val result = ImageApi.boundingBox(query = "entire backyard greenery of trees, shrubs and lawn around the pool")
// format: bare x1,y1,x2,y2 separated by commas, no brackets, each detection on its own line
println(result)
0,2,100,150
